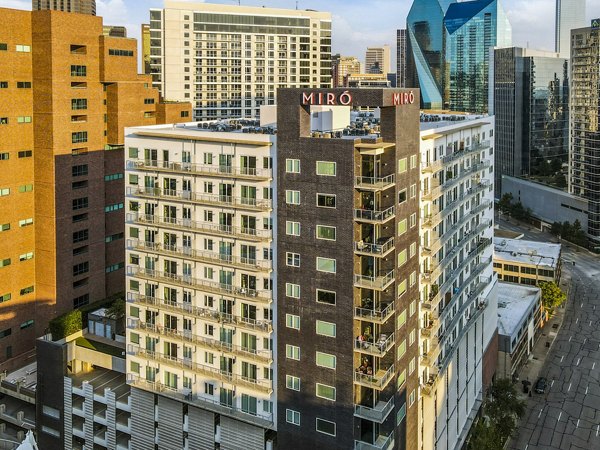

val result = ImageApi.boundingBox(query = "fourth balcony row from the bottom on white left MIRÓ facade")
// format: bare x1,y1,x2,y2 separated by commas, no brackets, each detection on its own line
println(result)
128,292,273,333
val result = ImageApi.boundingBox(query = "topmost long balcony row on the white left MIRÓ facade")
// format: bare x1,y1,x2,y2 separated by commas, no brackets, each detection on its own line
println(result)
127,158,273,181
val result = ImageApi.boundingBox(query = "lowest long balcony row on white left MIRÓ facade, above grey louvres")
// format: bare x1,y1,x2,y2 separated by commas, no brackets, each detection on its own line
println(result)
127,374,273,429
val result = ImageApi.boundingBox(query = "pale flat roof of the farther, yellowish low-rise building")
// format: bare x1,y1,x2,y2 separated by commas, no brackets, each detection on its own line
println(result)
494,237,561,269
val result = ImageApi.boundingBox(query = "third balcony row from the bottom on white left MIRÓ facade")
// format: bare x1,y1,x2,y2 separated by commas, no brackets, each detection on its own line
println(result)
132,319,273,364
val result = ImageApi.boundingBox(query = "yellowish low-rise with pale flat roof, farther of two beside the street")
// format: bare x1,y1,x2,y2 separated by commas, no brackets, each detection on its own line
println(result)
494,237,561,286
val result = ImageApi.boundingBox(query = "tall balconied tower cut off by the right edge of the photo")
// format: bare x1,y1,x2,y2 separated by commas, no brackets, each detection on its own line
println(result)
569,21,600,241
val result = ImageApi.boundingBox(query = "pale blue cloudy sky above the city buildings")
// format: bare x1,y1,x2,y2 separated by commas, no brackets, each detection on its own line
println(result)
0,0,600,66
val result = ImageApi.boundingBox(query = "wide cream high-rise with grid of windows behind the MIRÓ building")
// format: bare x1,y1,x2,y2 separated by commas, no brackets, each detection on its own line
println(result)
150,1,331,120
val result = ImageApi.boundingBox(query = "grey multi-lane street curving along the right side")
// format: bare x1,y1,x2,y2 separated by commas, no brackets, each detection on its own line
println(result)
497,220,600,450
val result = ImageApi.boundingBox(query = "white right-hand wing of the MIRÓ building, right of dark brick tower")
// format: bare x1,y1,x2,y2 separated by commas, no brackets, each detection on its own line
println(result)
418,115,498,449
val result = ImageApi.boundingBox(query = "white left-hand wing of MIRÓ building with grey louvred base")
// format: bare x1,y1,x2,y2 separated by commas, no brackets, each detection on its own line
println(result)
125,125,277,449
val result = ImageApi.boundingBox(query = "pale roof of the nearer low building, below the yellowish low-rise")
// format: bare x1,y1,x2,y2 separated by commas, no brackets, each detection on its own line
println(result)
498,281,541,336
